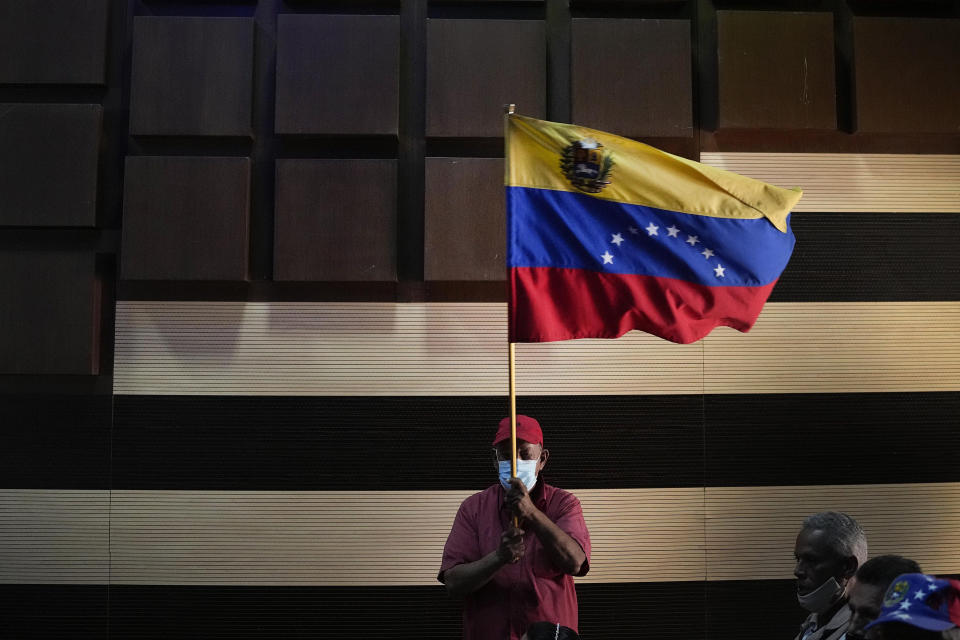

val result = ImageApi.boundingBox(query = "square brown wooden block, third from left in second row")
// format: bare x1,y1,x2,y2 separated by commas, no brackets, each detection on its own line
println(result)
274,160,397,281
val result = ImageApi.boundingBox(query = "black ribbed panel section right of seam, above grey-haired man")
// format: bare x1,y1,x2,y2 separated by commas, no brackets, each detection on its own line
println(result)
704,392,960,486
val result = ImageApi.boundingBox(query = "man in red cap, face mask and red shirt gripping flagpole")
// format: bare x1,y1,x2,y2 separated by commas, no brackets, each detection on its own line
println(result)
437,415,590,640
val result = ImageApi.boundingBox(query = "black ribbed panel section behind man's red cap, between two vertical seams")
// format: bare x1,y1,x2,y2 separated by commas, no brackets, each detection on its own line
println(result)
113,396,703,491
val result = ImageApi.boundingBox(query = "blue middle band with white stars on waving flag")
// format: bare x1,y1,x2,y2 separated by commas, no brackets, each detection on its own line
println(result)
507,187,794,287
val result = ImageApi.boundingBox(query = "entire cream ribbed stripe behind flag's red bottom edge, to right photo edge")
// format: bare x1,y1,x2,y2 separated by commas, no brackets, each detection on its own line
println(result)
114,301,960,396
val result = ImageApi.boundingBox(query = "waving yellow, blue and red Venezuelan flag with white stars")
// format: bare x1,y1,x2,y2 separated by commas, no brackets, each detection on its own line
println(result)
505,114,801,343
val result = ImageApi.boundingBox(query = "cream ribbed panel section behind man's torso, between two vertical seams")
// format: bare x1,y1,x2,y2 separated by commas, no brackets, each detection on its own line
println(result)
105,489,704,585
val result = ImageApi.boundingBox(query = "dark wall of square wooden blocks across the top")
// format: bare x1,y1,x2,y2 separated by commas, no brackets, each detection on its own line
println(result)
0,0,960,380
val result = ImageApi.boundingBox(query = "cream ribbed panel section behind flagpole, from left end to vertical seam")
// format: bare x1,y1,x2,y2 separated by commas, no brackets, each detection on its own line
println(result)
114,302,702,396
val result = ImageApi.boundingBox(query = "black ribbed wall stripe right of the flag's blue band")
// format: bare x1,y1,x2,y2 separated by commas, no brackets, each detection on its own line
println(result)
770,210,960,302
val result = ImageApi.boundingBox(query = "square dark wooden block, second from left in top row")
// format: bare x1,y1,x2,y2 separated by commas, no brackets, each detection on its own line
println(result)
130,16,253,136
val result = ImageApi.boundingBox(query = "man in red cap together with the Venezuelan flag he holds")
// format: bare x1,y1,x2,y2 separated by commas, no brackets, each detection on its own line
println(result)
438,112,801,640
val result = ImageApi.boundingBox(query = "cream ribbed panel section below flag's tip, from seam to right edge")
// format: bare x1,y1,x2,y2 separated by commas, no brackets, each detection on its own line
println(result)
703,302,960,393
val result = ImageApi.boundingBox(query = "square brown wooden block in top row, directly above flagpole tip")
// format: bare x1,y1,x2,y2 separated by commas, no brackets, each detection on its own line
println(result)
427,20,546,138
